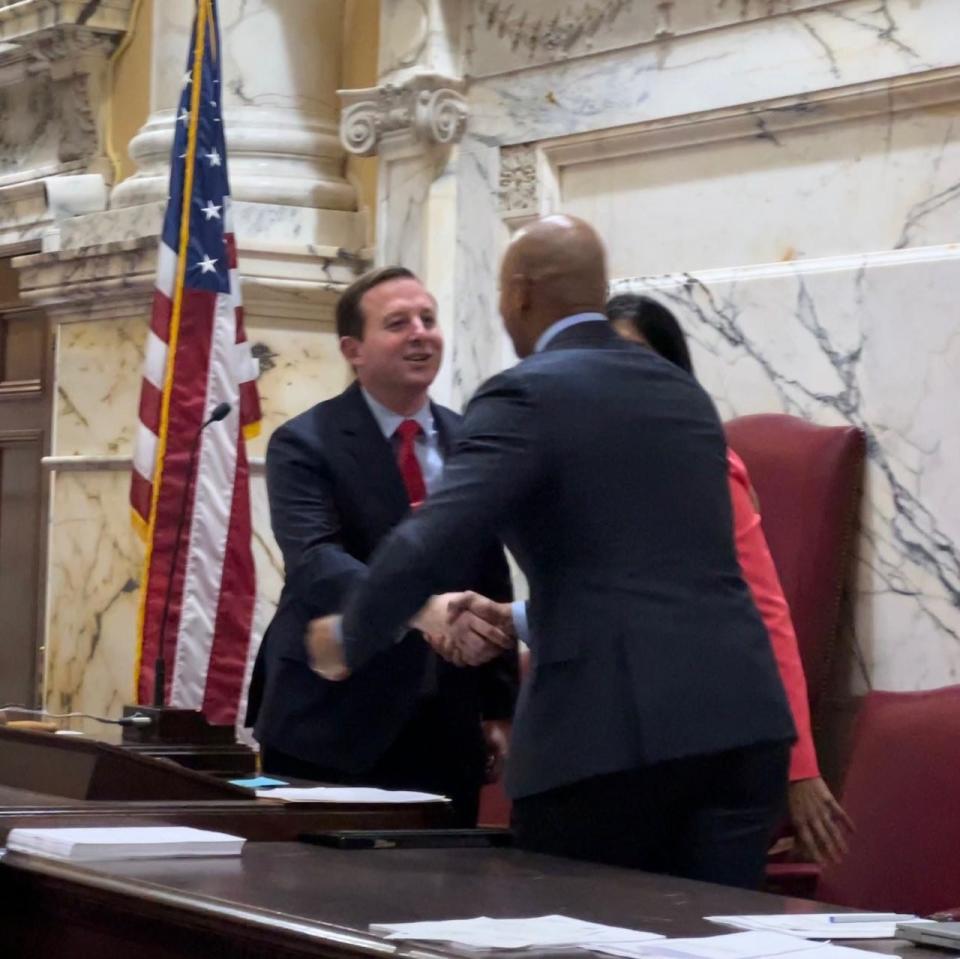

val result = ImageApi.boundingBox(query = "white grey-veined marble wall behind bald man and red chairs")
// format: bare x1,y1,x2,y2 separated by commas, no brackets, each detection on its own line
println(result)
440,0,960,693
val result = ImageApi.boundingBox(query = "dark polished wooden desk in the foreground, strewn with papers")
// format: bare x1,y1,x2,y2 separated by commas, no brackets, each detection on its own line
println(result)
0,843,941,959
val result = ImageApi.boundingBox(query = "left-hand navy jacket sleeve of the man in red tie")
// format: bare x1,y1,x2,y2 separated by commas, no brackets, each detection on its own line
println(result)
267,426,366,616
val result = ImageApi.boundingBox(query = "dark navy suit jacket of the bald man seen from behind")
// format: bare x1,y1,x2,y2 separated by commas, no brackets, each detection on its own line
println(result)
344,322,793,796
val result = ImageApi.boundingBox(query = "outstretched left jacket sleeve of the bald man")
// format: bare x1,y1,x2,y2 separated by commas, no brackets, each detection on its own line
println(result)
343,370,545,669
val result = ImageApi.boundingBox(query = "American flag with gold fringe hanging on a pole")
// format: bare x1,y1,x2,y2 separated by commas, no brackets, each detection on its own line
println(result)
130,0,260,724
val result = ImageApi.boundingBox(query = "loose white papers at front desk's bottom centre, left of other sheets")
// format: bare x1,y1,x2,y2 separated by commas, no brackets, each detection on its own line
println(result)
370,916,663,949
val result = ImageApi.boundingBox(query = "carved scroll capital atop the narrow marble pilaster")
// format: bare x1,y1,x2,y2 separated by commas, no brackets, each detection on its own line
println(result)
338,73,468,156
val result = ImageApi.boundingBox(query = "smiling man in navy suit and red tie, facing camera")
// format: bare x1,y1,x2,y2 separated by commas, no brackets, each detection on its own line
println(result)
247,267,517,825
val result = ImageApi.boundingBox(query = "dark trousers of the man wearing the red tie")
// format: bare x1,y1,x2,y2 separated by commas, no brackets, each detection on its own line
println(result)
260,698,485,828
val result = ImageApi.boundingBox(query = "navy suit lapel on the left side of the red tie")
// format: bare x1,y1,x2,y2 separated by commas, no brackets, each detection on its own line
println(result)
340,383,410,523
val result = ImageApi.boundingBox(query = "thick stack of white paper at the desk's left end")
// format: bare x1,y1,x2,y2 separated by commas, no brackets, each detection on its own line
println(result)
7,826,245,862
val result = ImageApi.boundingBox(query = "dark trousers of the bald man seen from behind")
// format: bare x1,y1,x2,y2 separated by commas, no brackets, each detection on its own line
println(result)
513,743,790,889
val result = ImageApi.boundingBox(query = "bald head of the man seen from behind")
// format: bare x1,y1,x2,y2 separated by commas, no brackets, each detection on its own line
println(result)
500,215,607,357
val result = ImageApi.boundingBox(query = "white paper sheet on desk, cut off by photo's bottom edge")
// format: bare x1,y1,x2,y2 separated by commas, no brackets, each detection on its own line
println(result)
595,932,896,959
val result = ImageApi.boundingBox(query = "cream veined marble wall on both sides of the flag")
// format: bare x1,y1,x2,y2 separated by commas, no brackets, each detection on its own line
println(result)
45,317,349,715
